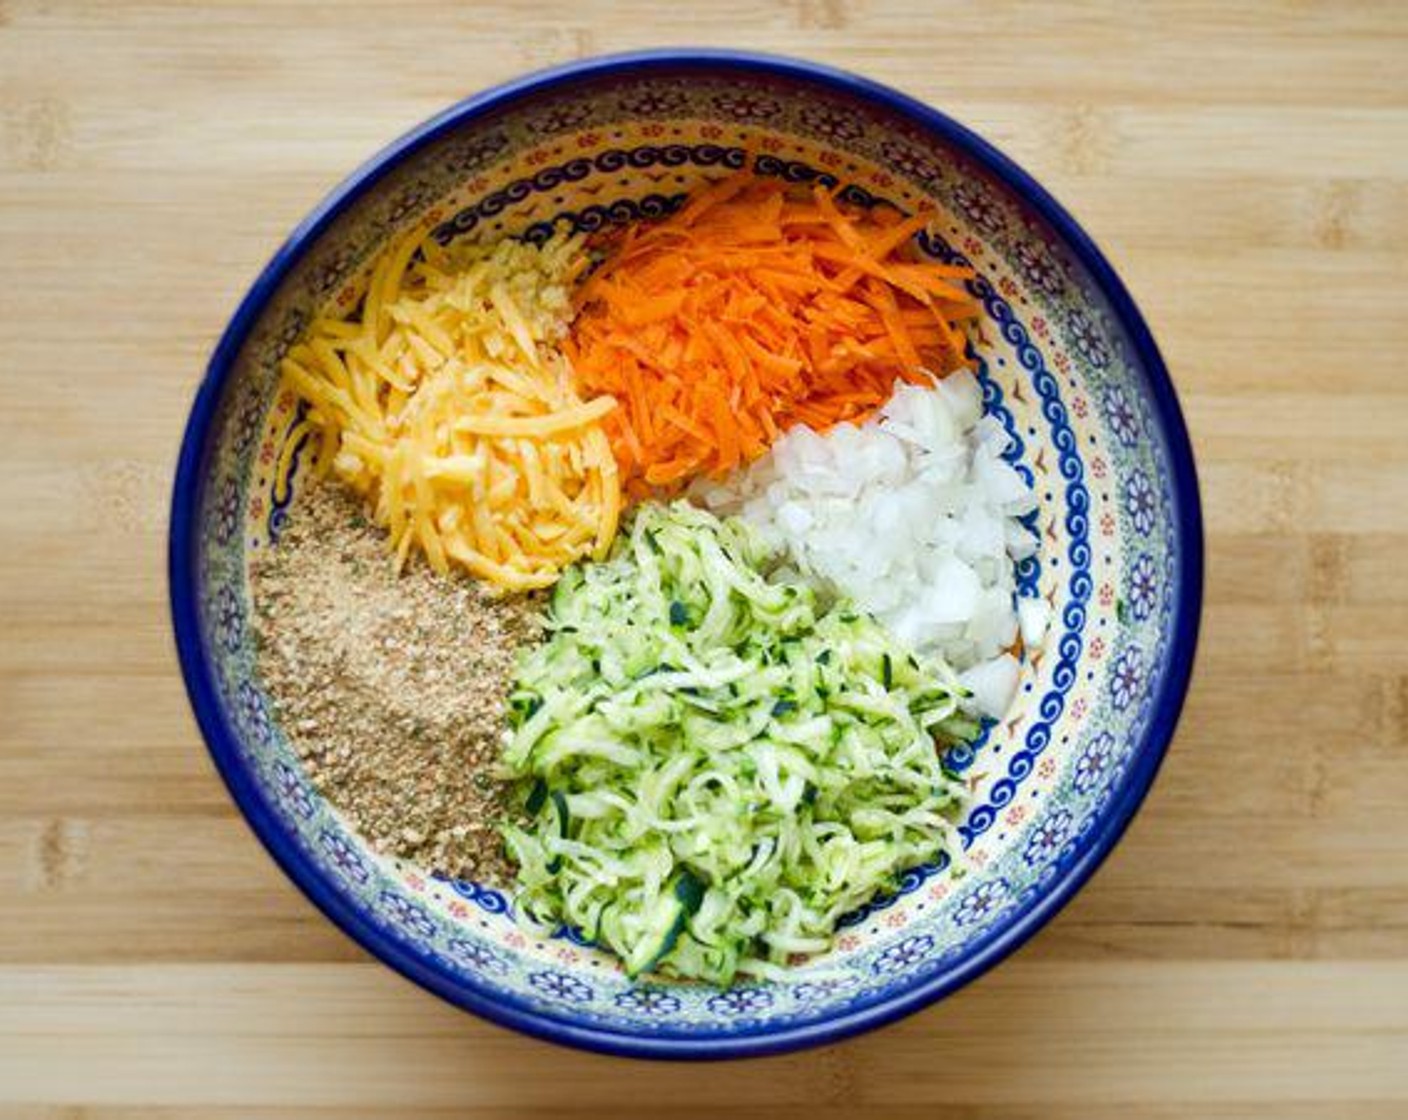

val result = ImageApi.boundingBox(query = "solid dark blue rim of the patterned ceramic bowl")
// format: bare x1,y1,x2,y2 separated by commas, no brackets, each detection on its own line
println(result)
168,48,1204,1059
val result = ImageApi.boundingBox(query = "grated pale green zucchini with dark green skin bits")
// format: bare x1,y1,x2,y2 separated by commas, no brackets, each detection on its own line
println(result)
503,503,977,983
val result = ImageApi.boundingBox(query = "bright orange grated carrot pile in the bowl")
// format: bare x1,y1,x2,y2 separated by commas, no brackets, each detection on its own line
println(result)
565,172,977,497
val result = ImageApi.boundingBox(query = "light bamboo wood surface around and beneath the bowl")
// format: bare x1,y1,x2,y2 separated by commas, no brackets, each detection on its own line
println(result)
0,0,1408,1120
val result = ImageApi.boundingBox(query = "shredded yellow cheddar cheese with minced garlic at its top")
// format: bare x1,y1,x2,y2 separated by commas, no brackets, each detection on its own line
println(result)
282,234,621,590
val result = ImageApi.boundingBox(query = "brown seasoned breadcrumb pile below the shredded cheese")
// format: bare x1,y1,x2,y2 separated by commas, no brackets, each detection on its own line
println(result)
252,483,541,885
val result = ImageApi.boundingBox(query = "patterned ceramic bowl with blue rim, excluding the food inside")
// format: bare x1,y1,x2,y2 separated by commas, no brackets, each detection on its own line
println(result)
170,51,1202,1057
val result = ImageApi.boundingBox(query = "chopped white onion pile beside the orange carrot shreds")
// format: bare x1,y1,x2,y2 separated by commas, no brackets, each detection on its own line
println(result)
694,371,1049,716
